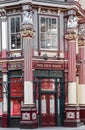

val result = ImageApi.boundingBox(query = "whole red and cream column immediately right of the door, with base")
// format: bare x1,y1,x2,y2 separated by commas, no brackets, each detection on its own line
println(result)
64,15,80,127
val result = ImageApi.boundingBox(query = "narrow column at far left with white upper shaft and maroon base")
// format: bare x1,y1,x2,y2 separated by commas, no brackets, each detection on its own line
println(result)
1,9,8,127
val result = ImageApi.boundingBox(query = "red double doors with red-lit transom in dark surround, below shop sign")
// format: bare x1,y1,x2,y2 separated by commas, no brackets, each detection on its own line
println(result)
34,75,65,127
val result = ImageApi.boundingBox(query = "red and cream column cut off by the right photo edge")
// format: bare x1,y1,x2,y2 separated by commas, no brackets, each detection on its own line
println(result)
78,17,85,123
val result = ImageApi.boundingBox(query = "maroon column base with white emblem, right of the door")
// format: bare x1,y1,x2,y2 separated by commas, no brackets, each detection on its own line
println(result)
64,106,81,127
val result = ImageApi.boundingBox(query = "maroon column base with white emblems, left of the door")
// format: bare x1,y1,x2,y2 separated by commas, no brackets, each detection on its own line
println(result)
20,104,38,129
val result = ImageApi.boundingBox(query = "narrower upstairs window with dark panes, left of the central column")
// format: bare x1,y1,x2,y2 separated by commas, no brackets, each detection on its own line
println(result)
10,16,21,49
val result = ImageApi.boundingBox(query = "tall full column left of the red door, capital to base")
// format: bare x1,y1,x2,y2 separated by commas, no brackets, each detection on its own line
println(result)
20,5,38,128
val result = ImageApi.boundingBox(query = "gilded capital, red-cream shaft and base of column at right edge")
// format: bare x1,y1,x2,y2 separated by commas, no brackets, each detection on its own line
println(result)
78,39,85,123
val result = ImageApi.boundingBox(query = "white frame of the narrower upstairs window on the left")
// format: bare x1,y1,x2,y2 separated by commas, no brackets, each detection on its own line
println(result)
9,15,22,51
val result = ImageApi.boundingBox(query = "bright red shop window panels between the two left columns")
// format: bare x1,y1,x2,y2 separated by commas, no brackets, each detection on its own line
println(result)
10,78,23,116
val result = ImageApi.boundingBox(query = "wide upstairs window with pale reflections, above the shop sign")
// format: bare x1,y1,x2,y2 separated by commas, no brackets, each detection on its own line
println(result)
39,16,58,50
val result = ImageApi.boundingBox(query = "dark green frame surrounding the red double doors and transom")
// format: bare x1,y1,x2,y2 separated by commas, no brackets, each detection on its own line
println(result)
34,70,65,126
